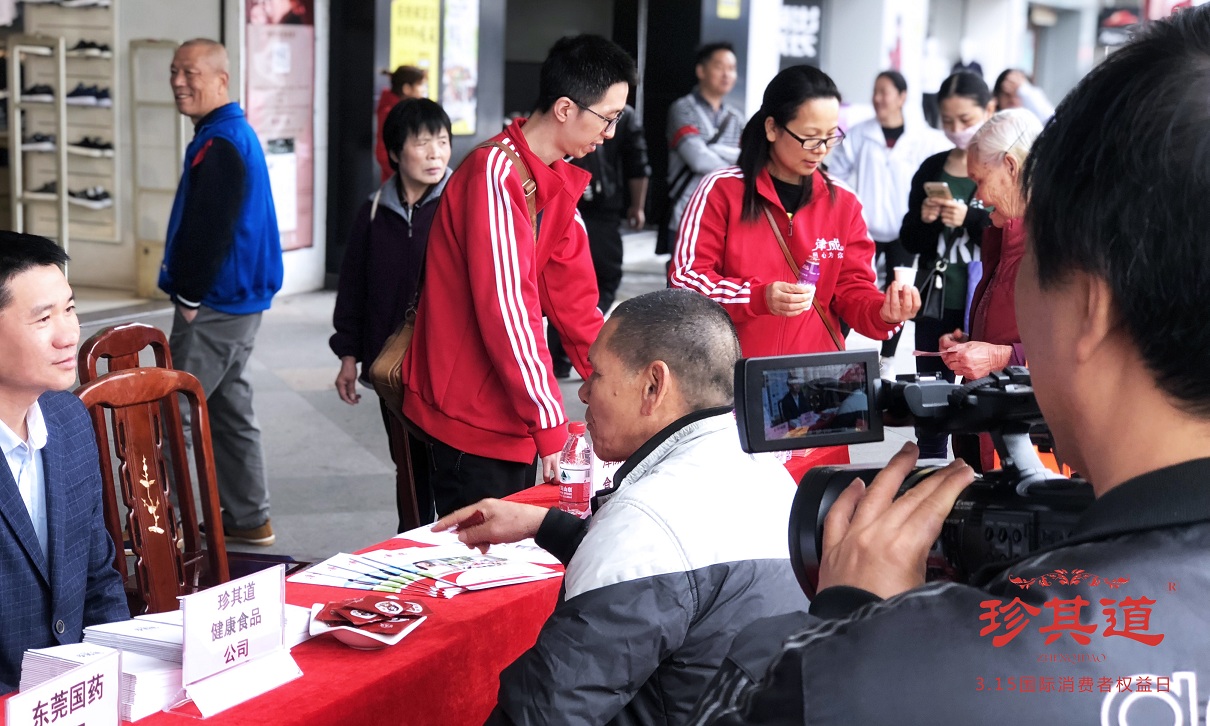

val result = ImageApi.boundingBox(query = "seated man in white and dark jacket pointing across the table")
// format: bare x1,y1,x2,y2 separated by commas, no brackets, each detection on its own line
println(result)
433,289,808,724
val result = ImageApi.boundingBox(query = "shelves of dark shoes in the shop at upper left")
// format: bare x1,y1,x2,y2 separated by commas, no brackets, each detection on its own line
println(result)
10,0,121,250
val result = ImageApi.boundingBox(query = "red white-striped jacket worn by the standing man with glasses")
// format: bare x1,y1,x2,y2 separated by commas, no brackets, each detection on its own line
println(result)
403,120,603,462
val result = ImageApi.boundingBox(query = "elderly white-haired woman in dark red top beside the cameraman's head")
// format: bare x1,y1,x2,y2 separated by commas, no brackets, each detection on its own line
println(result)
939,109,1042,471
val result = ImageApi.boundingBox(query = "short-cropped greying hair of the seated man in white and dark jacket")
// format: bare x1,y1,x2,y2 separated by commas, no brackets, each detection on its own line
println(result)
609,289,741,411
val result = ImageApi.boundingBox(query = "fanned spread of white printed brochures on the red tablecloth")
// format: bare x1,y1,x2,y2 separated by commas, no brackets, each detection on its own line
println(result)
289,545,561,598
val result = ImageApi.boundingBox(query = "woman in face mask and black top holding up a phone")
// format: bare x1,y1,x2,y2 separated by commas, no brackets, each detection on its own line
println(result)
899,73,992,459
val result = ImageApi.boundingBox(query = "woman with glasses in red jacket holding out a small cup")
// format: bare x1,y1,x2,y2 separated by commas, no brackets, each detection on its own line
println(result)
672,65,920,357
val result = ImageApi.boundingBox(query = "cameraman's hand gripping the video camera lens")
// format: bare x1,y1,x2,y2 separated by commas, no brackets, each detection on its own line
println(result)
819,443,974,598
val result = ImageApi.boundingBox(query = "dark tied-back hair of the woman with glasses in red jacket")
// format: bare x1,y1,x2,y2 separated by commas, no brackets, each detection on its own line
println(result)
738,65,840,221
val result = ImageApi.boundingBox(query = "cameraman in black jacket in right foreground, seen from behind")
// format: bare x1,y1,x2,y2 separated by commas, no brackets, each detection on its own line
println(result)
691,7,1210,725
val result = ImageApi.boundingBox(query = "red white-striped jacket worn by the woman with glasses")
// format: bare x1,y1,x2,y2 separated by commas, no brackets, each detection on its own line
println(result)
672,167,898,357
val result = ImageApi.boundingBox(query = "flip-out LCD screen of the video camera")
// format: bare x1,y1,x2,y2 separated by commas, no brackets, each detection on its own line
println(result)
736,351,882,451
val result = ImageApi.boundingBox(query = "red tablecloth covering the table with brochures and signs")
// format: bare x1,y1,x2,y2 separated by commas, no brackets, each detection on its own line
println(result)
0,446,848,726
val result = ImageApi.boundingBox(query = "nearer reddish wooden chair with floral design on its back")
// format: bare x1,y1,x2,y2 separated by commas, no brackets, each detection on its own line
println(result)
76,368,230,612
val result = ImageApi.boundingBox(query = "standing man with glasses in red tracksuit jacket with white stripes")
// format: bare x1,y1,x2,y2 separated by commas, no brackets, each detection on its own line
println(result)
403,35,634,515
